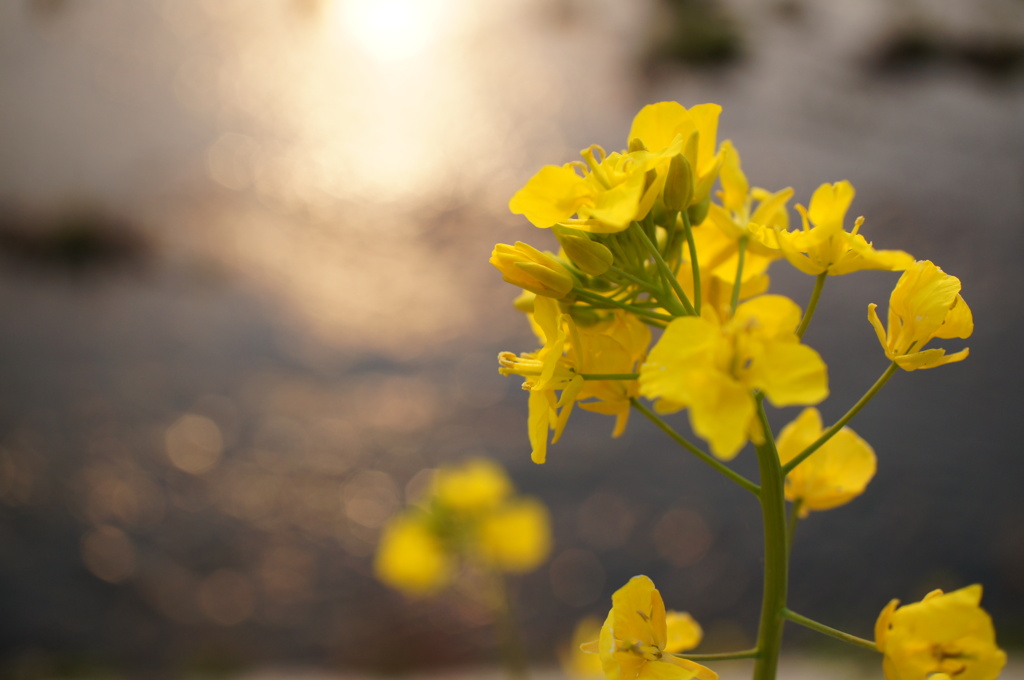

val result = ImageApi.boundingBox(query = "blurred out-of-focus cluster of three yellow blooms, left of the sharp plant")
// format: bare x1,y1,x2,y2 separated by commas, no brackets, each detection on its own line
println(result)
374,459,551,595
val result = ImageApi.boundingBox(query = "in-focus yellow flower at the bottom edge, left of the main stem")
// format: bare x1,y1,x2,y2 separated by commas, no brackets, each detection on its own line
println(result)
587,576,718,680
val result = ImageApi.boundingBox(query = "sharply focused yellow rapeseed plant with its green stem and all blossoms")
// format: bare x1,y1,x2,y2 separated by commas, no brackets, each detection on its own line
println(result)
490,102,991,680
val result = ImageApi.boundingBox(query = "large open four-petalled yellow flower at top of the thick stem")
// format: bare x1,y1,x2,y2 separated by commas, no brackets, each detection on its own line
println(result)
640,295,828,460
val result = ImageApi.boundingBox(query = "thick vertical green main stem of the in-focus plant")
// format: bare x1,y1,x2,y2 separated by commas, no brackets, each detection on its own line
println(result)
754,394,788,680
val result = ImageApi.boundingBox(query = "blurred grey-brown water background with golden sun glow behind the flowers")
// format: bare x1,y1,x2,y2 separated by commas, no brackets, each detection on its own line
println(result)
0,0,1024,678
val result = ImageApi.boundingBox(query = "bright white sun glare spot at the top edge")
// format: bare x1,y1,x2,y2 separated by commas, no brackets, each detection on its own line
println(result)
337,0,451,61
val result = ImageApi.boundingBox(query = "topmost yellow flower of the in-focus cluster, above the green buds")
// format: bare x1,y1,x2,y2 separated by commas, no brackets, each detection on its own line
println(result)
629,101,722,205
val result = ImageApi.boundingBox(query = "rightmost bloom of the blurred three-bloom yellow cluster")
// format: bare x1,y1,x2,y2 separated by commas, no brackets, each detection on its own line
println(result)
479,499,551,573
